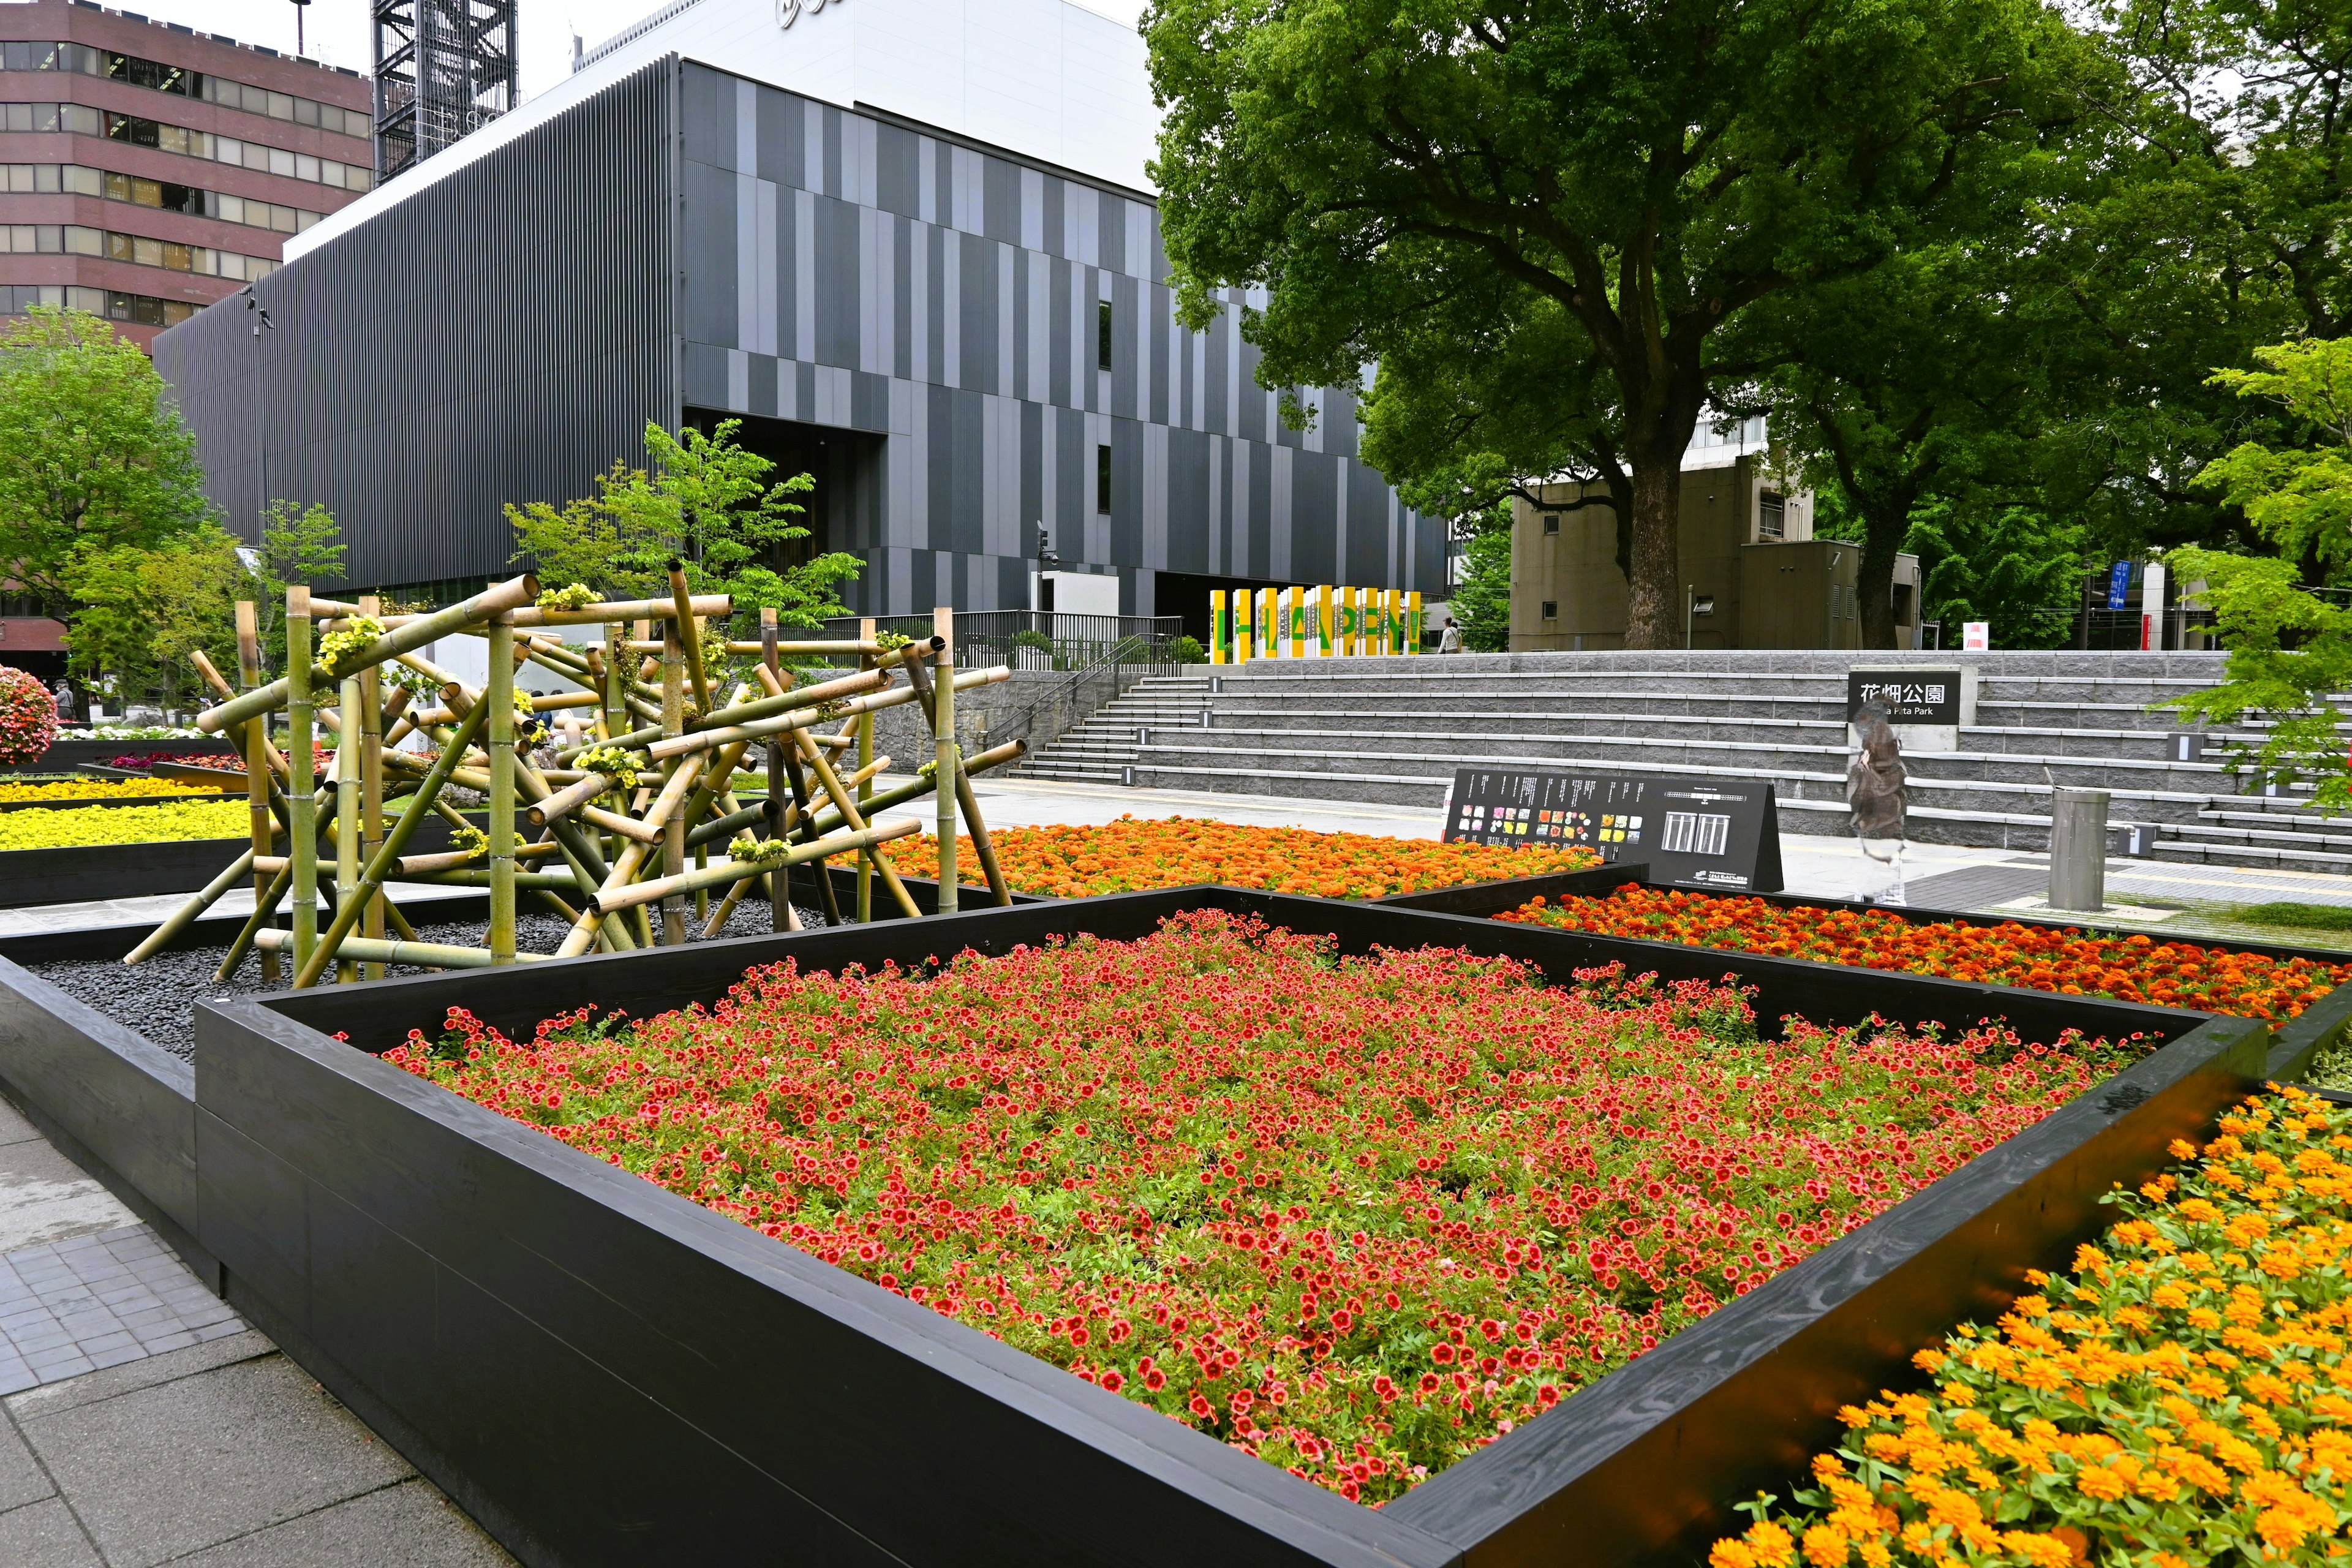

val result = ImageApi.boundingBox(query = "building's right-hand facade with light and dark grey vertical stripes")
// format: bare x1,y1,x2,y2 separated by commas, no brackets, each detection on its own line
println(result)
680,64,1444,614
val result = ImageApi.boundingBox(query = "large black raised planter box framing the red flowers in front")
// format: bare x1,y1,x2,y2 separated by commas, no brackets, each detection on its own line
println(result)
186,889,2270,1568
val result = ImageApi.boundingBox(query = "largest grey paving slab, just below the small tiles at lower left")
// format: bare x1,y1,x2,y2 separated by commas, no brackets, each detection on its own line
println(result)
17,1357,414,1568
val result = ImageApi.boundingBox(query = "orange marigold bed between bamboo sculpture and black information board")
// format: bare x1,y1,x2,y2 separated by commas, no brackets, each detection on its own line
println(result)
889,816,1599,898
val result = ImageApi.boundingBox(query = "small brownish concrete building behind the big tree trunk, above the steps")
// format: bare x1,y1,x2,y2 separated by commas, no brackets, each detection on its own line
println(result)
1510,418,1921,654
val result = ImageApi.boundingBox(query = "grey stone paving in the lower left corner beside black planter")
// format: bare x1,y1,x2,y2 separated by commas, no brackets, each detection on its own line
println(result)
0,1102,513,1568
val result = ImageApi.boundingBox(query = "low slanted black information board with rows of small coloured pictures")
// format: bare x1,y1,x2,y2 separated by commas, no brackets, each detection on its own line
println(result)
1444,769,1781,893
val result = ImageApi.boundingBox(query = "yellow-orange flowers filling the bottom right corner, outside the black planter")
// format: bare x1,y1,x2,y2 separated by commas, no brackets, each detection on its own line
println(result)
1710,1088,2352,1568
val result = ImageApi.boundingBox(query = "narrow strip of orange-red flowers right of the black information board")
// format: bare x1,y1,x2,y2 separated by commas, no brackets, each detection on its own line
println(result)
1496,884,2352,1020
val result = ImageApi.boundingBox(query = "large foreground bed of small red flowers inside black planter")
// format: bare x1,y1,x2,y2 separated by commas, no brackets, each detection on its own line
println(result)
386,912,2136,1502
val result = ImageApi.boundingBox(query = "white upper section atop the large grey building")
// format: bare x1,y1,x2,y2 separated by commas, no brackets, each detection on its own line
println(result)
285,0,1159,261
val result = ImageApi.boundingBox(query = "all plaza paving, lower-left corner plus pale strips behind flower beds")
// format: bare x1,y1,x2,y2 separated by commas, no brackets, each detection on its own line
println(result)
0,778,2352,1568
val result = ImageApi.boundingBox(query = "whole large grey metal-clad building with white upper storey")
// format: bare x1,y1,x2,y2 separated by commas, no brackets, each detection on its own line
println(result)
155,0,1444,614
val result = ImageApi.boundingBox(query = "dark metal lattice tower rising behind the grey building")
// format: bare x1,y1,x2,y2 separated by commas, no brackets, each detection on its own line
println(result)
374,0,520,181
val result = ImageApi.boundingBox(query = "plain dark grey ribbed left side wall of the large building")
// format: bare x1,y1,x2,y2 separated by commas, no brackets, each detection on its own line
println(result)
155,61,677,586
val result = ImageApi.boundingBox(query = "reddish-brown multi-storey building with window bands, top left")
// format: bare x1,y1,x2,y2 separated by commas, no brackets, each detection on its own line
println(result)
0,0,374,348
